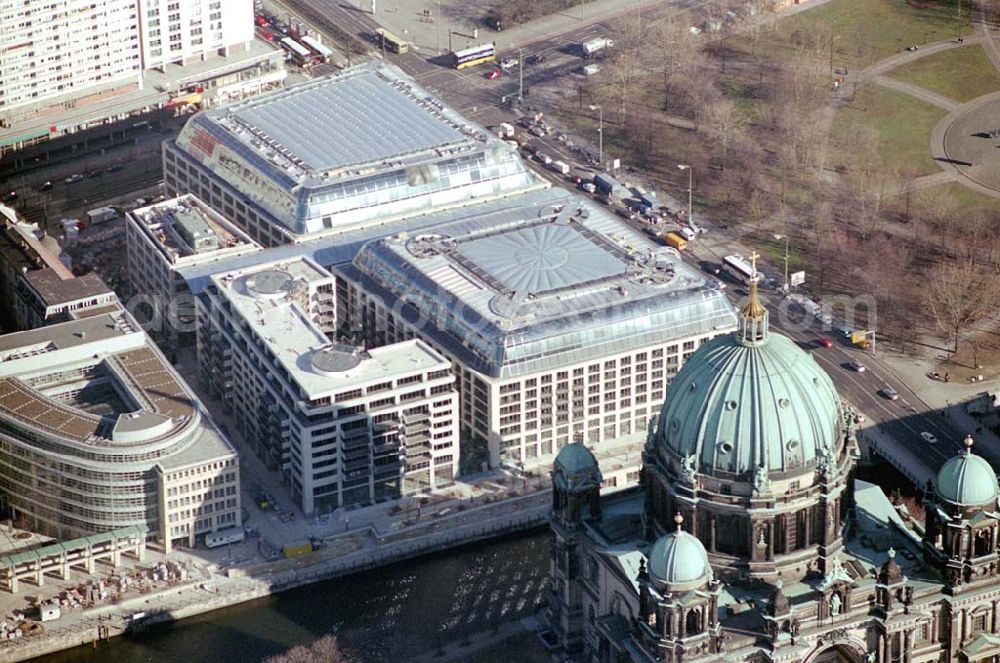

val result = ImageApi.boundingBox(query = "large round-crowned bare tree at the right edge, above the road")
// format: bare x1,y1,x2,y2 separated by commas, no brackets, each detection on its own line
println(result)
925,258,1000,352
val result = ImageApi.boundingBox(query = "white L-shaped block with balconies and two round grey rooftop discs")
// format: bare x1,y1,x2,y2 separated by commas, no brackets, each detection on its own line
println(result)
197,258,458,514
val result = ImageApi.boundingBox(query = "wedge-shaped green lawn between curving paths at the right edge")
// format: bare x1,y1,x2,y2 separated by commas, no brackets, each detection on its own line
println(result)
889,44,1000,101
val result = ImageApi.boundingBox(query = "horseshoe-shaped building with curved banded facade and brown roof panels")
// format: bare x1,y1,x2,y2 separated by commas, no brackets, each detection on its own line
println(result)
0,312,240,548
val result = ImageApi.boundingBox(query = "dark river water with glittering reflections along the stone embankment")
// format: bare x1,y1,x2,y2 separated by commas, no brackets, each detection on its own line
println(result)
37,529,549,663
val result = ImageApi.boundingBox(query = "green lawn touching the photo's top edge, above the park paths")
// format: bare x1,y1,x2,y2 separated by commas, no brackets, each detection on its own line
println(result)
778,0,972,67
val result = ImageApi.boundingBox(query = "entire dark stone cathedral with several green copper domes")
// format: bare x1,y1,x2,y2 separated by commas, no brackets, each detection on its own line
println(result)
548,272,1000,663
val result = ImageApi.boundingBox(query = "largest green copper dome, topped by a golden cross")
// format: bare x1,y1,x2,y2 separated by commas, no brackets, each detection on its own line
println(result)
655,300,840,474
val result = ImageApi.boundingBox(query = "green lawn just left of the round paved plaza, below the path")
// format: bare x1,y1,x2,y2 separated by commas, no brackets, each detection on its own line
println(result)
833,85,947,175
